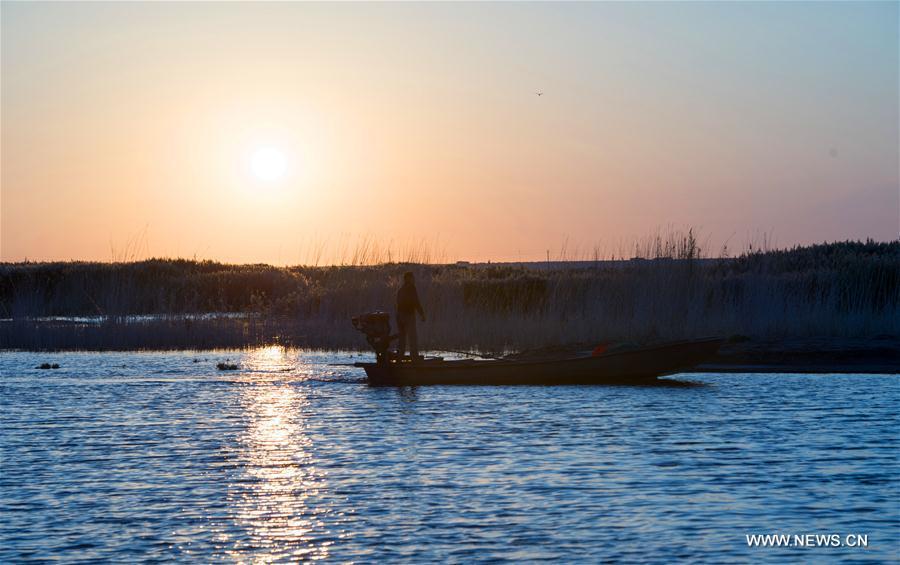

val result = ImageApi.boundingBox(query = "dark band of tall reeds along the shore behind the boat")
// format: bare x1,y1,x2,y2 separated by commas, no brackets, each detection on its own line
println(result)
0,237,900,372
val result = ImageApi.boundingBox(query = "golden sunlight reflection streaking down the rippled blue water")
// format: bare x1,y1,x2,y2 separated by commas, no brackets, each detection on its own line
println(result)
220,347,332,563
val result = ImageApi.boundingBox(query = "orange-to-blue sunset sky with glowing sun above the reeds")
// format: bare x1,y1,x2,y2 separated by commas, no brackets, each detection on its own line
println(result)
0,2,900,264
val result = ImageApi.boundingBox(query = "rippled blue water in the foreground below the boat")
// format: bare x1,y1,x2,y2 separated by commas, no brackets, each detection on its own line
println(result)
0,348,900,563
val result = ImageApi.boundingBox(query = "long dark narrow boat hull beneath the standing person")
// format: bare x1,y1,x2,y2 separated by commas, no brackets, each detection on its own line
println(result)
355,338,722,386
